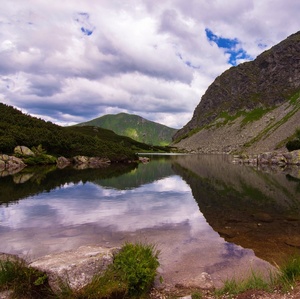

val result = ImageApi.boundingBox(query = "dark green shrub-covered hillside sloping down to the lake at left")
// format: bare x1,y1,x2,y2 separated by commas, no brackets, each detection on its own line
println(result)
0,103,166,161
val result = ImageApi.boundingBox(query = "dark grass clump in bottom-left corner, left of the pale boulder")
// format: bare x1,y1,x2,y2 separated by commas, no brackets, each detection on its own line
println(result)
0,260,54,299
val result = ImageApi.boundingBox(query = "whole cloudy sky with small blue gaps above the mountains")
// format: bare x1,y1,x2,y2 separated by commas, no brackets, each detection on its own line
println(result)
0,0,300,128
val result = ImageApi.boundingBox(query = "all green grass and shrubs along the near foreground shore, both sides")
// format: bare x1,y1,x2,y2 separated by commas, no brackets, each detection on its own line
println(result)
0,247,300,299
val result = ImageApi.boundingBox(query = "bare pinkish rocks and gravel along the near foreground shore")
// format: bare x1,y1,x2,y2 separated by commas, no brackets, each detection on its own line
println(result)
0,246,300,299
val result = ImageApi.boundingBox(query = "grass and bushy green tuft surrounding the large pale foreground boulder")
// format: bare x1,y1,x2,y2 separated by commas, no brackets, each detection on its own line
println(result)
0,243,159,299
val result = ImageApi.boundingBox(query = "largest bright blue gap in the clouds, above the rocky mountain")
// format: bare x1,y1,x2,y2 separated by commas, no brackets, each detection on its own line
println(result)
205,28,252,65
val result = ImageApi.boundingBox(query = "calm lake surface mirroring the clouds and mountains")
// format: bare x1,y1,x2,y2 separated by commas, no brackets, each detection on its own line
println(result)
0,155,300,284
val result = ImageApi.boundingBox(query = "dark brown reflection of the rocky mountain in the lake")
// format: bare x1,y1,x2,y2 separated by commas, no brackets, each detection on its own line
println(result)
174,155,300,263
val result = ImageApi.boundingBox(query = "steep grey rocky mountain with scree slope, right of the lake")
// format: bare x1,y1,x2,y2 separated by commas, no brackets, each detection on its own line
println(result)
173,31,300,153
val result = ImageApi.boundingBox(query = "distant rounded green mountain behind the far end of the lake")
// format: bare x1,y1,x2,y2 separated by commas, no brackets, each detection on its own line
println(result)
77,113,177,146
